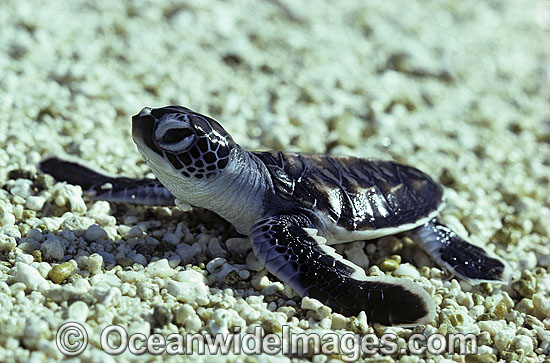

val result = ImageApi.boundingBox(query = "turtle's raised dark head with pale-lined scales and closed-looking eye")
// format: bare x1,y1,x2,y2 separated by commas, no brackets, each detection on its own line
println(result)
132,106,236,181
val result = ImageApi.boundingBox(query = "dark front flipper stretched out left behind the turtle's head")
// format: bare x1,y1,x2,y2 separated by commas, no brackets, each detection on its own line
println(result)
38,157,174,206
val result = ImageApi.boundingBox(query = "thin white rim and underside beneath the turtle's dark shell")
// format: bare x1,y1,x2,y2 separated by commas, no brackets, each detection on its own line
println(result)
325,203,444,245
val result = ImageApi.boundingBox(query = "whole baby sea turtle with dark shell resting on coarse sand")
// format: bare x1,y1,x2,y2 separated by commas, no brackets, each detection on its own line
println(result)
40,106,506,326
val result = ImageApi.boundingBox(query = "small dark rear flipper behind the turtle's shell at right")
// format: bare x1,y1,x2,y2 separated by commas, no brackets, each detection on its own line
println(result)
408,218,508,284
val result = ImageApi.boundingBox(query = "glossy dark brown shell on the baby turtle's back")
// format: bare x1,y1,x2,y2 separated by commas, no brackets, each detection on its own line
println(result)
252,151,443,231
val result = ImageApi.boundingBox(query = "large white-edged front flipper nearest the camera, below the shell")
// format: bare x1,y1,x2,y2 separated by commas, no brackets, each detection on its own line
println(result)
251,214,435,326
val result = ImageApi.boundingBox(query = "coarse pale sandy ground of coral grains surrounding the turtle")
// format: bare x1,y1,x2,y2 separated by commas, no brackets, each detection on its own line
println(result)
0,0,550,362
